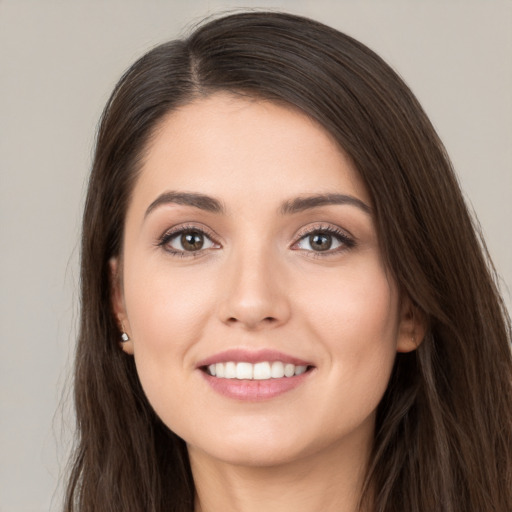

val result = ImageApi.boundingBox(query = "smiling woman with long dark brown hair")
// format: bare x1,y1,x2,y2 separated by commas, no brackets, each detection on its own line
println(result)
66,12,512,512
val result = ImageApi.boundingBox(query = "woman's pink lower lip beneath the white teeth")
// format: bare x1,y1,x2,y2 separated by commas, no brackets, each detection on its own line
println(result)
201,370,311,402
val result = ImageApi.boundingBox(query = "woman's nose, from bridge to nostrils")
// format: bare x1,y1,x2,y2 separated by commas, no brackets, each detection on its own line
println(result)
220,248,291,331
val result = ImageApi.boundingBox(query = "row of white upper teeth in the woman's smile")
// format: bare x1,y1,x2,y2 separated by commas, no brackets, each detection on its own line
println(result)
207,361,308,380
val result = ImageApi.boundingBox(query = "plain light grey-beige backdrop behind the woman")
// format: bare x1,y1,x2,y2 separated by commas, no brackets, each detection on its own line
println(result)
0,0,512,512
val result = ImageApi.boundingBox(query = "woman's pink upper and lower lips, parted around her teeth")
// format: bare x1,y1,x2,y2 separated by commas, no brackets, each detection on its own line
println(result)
197,349,314,402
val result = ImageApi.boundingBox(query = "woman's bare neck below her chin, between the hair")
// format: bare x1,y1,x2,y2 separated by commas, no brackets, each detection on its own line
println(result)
189,432,369,512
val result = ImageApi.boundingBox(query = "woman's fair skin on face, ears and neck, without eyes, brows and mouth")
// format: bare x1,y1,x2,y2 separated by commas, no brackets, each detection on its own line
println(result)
111,93,422,512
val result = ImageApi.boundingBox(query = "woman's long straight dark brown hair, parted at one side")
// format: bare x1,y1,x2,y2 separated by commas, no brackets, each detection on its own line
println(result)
65,12,512,512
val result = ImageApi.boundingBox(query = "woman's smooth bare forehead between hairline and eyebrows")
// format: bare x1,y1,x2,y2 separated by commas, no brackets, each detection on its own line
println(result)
129,93,369,214
